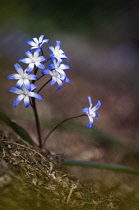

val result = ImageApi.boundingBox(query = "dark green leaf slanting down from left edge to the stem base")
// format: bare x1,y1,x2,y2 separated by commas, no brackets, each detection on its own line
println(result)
0,111,35,145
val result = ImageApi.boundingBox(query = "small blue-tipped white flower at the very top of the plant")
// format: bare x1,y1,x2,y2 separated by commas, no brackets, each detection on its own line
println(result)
27,35,49,50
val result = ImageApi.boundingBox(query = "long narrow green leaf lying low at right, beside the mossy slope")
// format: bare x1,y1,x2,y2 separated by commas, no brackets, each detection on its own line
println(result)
61,160,139,175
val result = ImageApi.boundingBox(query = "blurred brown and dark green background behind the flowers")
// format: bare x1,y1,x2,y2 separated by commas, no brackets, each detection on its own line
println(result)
0,0,139,208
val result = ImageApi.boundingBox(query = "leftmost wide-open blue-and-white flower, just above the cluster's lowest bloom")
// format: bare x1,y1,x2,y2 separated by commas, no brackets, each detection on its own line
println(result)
7,63,38,90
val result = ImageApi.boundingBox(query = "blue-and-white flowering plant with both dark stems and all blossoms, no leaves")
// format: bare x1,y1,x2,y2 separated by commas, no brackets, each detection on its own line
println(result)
7,35,101,149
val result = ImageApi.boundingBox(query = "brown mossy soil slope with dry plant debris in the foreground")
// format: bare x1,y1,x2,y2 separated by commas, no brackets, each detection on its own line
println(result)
0,131,126,210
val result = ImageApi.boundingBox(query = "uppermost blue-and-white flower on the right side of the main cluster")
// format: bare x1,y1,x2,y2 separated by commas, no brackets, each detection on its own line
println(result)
48,41,70,61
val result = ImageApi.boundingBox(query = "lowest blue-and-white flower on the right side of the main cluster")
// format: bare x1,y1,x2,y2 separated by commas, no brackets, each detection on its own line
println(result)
42,69,70,90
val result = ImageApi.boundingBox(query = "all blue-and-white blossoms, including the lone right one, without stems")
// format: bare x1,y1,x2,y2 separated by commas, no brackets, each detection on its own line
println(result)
8,35,101,128
